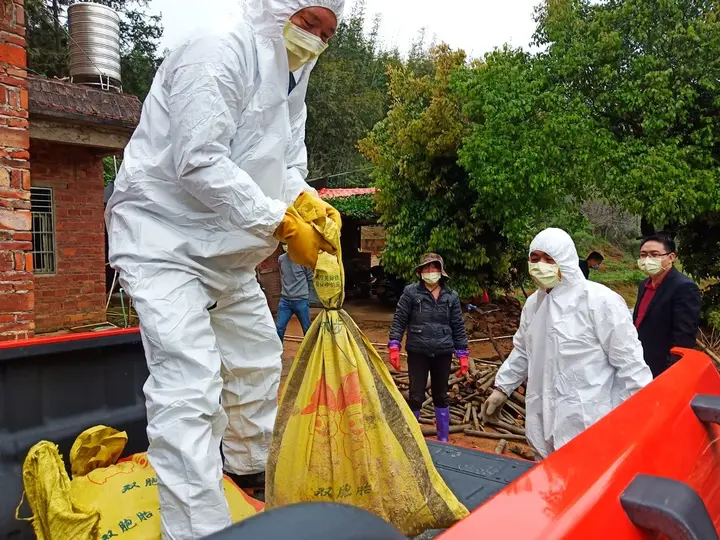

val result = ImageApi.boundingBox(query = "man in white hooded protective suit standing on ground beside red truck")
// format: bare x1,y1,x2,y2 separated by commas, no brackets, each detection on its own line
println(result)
482,229,652,458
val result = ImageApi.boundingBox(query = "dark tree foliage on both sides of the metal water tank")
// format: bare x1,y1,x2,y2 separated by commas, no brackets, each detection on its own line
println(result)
25,0,163,100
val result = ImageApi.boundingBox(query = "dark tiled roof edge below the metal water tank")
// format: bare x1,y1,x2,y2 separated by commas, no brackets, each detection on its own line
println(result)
29,77,141,129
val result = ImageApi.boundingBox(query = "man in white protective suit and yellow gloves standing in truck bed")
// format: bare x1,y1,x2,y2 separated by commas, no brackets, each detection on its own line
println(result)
106,0,344,540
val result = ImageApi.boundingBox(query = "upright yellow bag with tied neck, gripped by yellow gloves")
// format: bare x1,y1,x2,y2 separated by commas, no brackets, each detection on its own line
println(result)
265,201,468,536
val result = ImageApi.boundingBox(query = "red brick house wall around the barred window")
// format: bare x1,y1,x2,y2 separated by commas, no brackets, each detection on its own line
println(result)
30,140,106,332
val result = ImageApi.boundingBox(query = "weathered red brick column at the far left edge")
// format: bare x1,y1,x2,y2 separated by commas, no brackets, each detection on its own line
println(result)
0,0,35,340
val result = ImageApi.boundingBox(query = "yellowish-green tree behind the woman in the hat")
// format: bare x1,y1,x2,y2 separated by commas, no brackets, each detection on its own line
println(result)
360,46,515,295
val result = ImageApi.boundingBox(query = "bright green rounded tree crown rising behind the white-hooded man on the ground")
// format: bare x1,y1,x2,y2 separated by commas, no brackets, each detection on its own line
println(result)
453,48,603,249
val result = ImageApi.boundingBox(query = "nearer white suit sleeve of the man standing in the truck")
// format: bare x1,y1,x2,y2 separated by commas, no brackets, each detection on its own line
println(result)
168,54,287,238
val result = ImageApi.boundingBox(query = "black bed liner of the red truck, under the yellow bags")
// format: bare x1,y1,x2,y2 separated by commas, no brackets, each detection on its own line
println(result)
0,333,532,540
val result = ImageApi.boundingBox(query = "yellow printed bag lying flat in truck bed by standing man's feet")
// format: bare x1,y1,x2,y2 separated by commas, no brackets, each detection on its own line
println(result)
23,426,263,540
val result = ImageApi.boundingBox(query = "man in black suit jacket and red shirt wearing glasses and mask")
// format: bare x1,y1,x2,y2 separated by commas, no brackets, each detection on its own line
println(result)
633,235,700,377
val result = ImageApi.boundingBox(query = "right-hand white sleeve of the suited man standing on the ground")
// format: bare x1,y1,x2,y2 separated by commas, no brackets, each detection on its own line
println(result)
590,293,652,401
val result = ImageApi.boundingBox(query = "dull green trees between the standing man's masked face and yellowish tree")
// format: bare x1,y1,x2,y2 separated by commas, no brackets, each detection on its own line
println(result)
305,2,400,187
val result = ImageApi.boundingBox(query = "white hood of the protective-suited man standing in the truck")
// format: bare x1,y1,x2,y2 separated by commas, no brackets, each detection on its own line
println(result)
244,0,345,38
